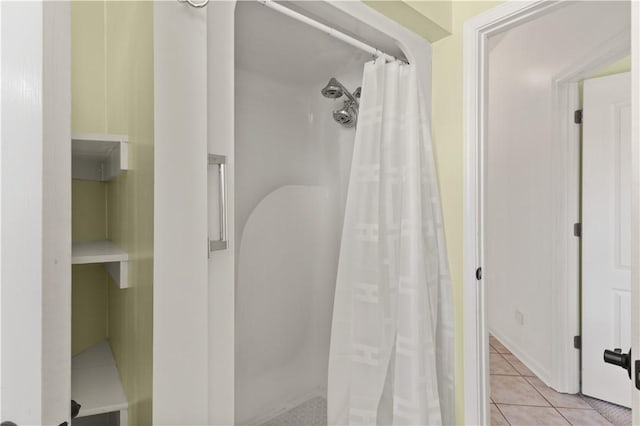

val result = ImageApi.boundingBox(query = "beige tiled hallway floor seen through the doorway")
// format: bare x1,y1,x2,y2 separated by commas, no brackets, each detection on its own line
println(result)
489,336,631,426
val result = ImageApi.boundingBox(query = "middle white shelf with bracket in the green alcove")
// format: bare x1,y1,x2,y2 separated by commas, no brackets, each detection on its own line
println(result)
71,240,129,288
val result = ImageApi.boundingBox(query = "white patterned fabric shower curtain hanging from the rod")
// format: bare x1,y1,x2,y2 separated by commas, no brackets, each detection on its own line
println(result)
327,59,455,426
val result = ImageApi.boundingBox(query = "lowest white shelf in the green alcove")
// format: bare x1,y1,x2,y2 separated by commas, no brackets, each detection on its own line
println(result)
71,341,129,417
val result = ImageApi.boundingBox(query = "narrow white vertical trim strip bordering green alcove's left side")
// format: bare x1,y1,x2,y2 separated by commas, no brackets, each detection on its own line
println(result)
42,2,71,425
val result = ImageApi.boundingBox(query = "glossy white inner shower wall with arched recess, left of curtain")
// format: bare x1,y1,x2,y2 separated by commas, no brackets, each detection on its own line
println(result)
234,3,368,424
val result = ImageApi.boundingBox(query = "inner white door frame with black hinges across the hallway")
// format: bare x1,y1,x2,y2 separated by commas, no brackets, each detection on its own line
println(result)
549,30,631,393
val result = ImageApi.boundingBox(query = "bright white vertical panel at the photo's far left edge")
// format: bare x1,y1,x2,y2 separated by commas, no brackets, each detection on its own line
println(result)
0,2,43,424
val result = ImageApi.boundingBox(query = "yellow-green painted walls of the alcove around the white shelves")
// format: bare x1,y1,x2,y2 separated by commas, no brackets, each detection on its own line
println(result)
71,1,153,425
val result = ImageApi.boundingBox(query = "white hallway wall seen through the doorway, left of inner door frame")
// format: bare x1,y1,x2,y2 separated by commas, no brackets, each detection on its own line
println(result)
485,2,629,383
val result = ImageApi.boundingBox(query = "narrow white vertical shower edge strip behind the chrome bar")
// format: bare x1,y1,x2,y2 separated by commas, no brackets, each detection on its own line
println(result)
207,1,236,425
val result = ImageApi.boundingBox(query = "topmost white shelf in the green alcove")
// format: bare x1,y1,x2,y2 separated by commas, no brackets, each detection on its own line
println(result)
71,133,129,181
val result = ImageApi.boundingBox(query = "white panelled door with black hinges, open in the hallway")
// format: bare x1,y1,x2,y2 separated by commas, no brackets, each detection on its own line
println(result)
582,73,632,407
